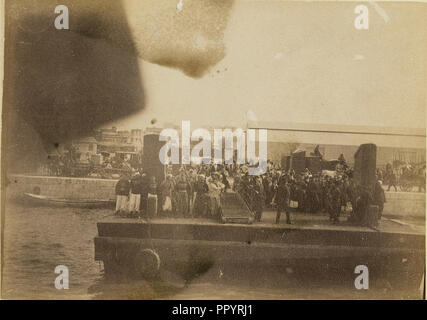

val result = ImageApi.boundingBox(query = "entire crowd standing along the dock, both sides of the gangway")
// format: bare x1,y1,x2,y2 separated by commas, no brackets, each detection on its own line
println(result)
116,163,385,224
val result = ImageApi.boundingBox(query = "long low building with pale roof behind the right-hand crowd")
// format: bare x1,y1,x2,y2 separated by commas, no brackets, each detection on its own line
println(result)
248,121,426,168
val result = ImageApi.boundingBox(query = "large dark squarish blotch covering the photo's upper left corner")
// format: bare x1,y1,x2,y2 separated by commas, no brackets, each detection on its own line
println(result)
2,0,145,173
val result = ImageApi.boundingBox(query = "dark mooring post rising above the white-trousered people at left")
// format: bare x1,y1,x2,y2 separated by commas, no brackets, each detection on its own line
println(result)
142,134,165,183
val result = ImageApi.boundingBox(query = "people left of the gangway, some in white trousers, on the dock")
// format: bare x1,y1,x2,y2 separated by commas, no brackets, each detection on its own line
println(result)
116,167,232,218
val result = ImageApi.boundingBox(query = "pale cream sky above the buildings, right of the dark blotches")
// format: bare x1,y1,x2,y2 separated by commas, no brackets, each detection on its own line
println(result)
106,0,427,129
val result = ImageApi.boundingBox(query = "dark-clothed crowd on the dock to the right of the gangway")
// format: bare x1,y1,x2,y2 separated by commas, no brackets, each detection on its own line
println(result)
236,167,386,224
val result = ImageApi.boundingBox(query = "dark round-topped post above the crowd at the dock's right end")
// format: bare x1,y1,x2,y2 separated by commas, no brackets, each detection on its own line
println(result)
354,143,377,187
